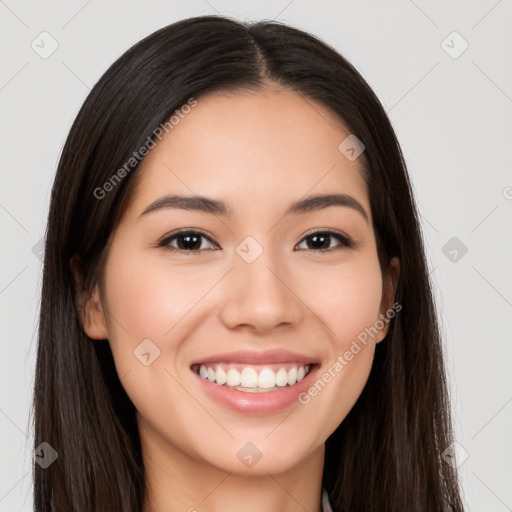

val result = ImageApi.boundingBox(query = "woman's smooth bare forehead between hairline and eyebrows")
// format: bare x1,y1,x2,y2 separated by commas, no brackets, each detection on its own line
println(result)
127,89,370,218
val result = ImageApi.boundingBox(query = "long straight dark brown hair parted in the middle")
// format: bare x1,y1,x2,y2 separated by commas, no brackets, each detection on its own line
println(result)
33,16,463,512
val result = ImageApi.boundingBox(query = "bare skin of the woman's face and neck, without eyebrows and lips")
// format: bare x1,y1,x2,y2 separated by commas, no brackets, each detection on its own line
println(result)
76,88,398,512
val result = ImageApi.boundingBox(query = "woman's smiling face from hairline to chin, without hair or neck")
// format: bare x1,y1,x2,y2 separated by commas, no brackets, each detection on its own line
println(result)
84,89,400,474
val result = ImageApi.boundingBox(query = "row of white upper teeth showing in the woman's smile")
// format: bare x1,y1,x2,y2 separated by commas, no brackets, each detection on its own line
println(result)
195,364,310,392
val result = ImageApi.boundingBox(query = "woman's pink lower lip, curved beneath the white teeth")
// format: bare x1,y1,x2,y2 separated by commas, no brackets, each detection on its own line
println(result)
191,365,318,414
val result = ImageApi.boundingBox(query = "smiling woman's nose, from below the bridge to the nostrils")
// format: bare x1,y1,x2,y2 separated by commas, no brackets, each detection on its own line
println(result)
220,246,305,334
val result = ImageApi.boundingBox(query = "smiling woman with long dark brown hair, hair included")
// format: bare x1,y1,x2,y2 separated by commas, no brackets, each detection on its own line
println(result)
34,16,462,512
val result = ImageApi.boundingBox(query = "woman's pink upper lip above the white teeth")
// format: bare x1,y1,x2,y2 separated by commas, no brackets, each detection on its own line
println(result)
191,349,317,366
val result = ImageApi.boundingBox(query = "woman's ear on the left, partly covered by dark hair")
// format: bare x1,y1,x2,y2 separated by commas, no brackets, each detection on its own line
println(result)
69,255,108,340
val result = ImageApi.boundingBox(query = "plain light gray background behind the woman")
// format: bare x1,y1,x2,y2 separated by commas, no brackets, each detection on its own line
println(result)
0,0,512,512
